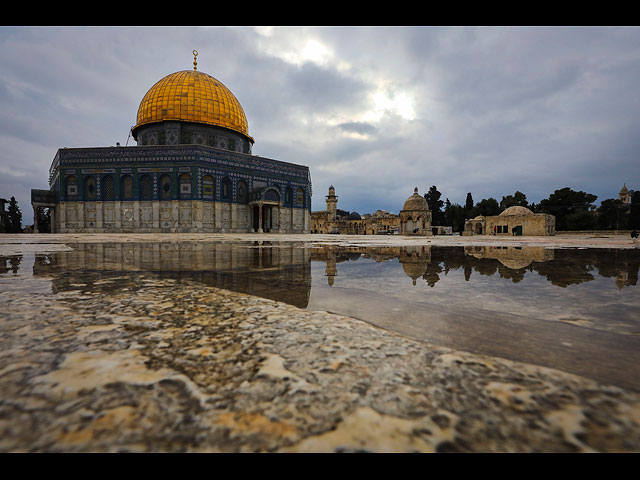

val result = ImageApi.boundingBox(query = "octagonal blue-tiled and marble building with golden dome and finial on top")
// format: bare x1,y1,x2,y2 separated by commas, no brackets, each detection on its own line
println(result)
31,51,311,233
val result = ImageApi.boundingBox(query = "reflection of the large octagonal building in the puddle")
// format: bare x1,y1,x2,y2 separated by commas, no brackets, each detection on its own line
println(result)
34,242,311,308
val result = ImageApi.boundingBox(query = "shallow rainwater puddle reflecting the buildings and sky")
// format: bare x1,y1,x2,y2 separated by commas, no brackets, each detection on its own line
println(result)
0,242,640,391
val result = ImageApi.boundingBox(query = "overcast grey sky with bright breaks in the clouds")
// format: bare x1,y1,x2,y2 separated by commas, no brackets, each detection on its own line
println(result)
0,27,640,225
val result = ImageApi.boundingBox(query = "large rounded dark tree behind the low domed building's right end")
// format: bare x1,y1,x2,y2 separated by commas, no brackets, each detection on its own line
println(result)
537,187,598,231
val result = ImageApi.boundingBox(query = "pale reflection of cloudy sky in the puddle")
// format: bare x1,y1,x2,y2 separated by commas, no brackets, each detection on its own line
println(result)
310,253,640,333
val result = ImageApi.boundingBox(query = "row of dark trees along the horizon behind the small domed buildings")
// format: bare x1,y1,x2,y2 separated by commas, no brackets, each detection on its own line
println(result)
424,185,640,232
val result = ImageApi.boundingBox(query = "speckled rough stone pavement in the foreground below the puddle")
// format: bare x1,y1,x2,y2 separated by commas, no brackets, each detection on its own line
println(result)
0,234,640,452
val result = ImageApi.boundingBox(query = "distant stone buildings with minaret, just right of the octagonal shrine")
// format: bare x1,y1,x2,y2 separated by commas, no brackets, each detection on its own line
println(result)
311,185,400,235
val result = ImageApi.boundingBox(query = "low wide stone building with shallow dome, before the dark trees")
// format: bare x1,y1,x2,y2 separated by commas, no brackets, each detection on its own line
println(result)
463,206,556,236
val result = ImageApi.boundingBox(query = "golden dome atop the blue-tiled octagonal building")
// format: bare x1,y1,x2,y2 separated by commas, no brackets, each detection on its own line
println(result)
134,69,253,142
